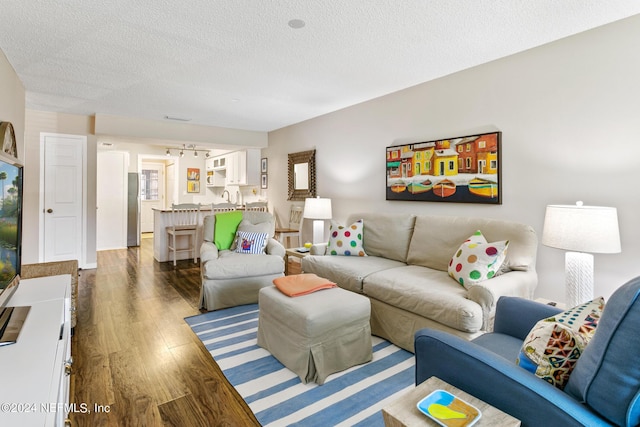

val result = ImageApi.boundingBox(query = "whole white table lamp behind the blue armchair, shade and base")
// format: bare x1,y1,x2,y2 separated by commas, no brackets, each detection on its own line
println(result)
542,202,621,307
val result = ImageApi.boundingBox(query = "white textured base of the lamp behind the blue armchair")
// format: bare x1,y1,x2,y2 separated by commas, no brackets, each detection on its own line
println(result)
564,252,593,307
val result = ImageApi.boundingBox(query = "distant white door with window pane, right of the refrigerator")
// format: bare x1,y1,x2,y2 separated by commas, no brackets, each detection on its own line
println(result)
140,162,165,233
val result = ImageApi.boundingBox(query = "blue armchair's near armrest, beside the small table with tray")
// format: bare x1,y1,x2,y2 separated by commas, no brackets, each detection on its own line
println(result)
415,329,609,427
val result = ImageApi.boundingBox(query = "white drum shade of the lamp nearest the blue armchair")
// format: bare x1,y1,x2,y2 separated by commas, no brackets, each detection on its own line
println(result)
542,204,621,254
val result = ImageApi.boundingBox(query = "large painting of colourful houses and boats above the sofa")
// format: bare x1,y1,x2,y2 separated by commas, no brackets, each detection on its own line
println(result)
386,132,502,204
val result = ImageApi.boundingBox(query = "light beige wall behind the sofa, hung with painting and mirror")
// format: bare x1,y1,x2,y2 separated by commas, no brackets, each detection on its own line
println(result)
263,16,640,301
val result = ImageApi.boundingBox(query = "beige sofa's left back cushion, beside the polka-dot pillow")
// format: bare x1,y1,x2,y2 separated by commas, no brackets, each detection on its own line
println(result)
346,212,416,262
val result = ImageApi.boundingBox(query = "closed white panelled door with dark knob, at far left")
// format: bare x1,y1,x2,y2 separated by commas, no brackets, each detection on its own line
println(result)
40,134,87,265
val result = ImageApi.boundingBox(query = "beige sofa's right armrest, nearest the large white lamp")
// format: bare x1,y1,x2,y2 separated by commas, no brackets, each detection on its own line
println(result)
467,271,538,331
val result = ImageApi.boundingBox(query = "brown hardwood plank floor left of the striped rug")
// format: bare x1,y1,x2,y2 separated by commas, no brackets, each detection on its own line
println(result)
70,239,260,427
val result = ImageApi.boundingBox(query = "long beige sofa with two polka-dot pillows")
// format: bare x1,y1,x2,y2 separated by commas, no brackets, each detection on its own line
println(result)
302,213,538,351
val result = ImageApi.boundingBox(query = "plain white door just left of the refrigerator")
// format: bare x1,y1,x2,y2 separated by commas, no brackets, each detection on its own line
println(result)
96,151,129,251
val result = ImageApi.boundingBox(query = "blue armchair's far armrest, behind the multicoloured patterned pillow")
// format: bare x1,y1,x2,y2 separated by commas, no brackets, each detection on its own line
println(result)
493,297,562,341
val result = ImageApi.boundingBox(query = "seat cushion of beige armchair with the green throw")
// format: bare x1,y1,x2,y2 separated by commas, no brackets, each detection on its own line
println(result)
203,250,284,279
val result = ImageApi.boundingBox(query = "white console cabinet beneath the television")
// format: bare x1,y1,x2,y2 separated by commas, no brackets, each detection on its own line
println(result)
0,274,72,427
